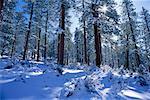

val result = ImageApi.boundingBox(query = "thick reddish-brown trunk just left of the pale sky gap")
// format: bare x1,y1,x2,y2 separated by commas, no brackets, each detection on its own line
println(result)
58,2,65,65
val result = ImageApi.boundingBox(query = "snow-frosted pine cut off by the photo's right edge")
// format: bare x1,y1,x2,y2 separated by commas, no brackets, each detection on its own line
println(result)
139,7,150,71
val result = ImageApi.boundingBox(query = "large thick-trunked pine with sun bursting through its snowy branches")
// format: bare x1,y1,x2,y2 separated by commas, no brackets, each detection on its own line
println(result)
91,0,119,66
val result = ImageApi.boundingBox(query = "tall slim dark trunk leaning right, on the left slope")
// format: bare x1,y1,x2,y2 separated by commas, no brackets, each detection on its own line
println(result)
23,3,34,60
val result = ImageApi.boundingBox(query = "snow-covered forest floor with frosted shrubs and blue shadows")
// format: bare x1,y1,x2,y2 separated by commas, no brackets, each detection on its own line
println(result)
0,58,150,100
